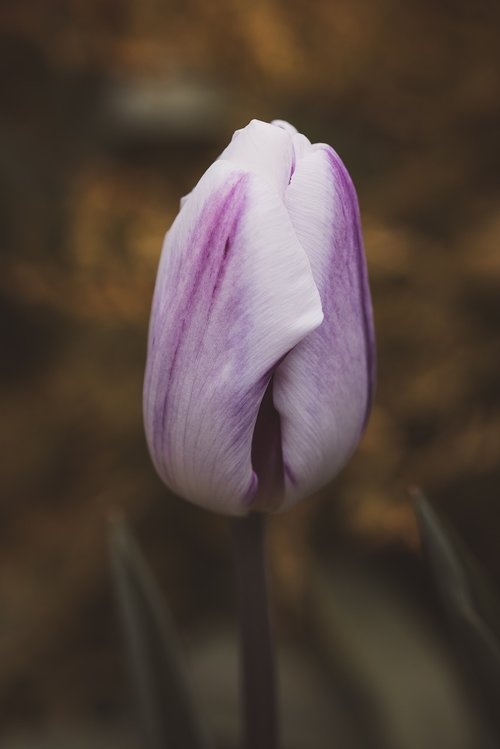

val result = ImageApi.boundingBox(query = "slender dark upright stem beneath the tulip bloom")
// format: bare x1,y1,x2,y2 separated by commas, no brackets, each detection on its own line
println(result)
232,512,278,749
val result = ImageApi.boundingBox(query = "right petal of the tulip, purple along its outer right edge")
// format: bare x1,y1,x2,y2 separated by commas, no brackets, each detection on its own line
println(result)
273,144,375,506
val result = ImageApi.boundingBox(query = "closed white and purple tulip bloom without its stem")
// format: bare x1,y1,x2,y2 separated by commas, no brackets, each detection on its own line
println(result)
144,120,375,515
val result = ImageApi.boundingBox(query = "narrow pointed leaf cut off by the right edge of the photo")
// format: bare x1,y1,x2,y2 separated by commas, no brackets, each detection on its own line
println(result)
415,492,500,728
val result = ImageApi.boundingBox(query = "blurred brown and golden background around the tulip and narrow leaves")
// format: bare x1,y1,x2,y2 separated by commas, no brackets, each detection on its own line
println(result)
0,0,500,749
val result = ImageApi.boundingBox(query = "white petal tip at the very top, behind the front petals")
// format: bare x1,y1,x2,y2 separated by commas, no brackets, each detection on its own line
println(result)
219,120,294,196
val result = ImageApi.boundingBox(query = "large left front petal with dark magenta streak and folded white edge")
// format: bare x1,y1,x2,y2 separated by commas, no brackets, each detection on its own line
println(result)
144,155,323,514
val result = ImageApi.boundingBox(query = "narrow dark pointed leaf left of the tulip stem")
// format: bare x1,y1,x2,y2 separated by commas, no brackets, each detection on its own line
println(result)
110,520,208,749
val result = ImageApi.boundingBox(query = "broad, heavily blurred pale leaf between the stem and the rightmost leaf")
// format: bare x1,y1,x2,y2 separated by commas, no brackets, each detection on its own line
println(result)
308,552,476,749
